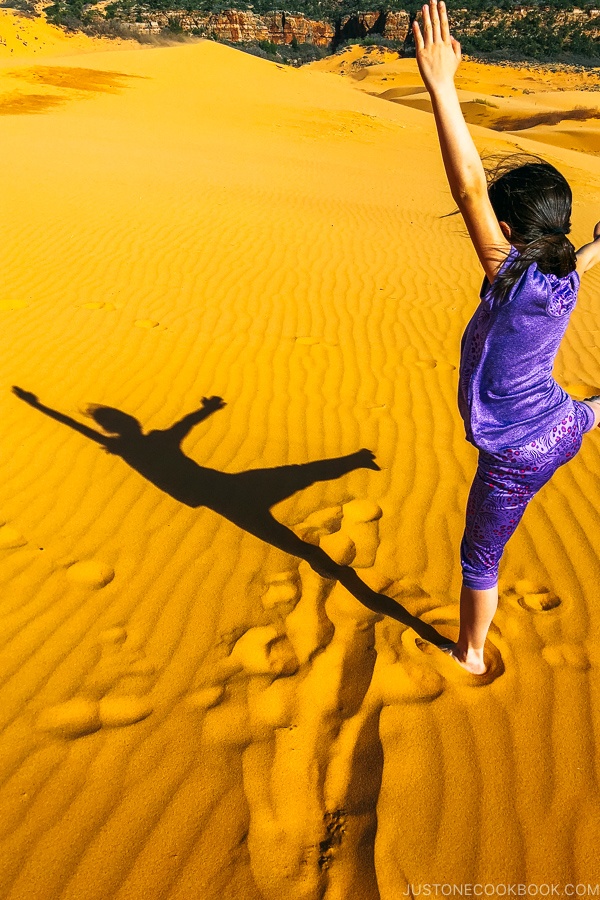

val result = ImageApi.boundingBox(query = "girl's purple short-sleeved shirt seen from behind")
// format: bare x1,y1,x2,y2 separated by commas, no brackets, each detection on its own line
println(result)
458,247,579,453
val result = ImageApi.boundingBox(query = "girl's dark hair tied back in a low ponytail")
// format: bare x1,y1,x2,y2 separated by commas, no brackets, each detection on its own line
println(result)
488,155,577,302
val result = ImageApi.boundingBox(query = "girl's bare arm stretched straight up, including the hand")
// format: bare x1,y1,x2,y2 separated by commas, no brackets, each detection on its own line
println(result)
413,0,510,283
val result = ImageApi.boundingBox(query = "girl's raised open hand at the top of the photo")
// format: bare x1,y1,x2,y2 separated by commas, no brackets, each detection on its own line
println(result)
413,0,461,91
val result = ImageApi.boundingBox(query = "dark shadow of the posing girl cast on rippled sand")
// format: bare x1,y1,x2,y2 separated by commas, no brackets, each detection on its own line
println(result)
13,387,448,646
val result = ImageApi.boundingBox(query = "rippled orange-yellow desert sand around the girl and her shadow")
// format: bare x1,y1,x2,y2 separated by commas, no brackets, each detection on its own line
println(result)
0,14,600,900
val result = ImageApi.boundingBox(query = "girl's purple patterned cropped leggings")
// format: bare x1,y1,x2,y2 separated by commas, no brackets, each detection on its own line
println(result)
460,400,594,590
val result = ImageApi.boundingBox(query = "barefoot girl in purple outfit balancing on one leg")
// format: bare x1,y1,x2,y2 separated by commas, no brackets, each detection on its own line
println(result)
413,0,600,675
